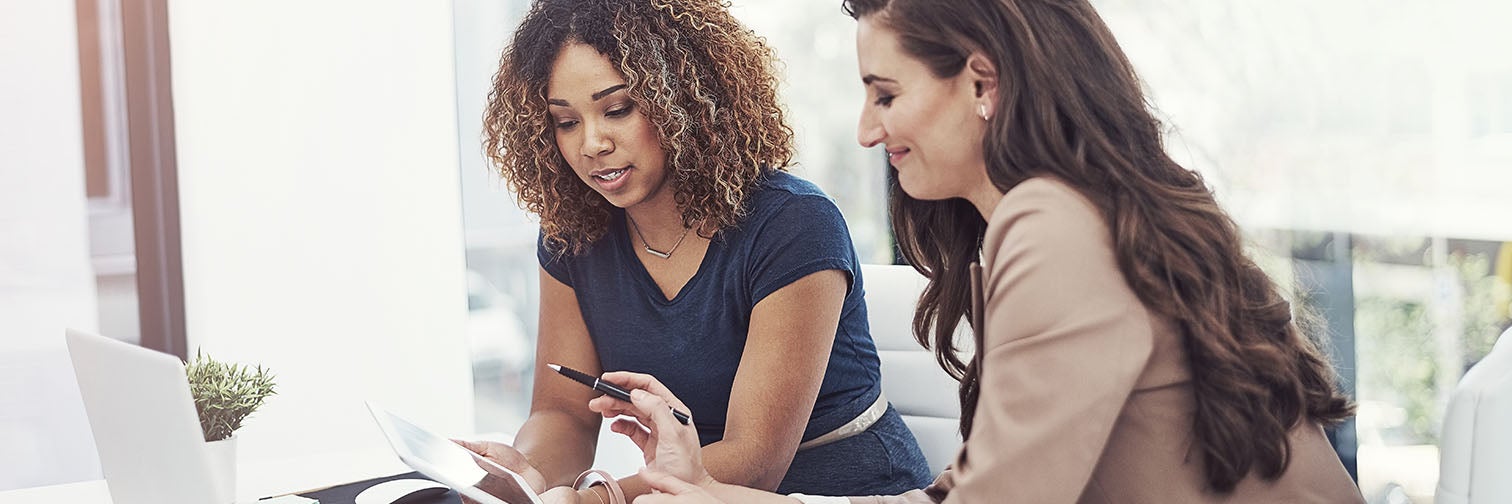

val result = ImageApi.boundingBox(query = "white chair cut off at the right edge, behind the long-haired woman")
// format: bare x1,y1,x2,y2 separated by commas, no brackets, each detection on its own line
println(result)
1433,325,1512,504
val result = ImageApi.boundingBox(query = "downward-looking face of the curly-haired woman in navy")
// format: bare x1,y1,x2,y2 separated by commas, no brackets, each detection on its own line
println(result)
546,42,671,209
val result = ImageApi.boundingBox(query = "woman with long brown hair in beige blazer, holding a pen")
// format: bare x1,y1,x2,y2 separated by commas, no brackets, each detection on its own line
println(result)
590,0,1361,502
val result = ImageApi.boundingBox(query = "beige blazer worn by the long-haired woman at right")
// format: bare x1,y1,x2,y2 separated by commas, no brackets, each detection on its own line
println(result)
853,179,1364,504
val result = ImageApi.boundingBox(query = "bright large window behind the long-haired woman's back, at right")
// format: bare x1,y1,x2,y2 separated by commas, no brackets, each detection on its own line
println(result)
1093,0,1512,502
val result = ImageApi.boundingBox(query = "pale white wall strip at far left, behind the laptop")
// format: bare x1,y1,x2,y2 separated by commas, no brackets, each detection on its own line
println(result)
0,2,100,490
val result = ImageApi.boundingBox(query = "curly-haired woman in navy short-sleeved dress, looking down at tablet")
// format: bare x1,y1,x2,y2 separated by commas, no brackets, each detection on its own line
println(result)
467,0,930,502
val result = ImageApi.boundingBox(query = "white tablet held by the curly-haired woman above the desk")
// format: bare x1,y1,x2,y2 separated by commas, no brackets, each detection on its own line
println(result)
367,403,543,504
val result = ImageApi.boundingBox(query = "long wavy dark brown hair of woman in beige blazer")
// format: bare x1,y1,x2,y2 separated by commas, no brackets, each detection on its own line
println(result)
844,0,1353,492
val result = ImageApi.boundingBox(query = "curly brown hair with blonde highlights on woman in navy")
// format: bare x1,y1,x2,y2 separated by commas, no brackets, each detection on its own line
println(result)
484,0,794,253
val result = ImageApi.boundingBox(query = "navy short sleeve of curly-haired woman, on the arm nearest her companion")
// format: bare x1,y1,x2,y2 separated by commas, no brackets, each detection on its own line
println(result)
748,194,859,306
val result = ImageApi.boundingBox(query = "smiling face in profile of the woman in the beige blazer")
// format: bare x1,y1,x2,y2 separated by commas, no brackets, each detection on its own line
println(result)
856,15,990,200
